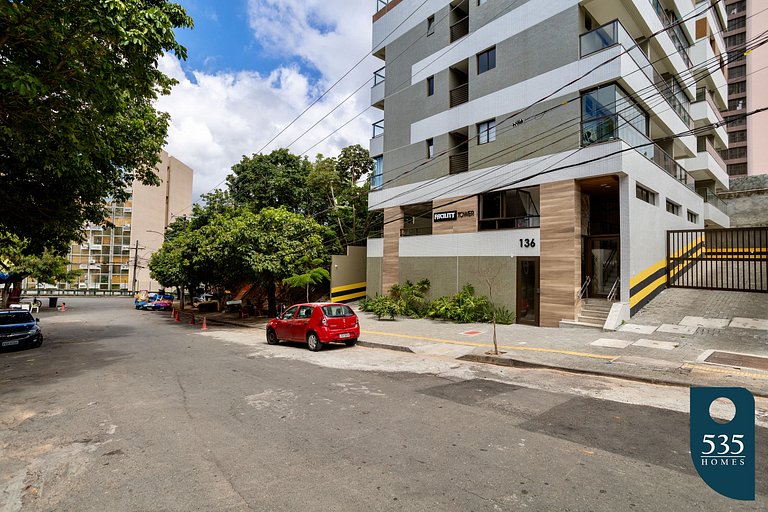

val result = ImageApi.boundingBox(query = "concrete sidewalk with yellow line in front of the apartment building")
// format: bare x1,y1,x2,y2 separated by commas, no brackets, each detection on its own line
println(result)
171,302,768,397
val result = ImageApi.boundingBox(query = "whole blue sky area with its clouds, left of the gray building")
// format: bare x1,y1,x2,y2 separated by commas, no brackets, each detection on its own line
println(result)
157,0,382,206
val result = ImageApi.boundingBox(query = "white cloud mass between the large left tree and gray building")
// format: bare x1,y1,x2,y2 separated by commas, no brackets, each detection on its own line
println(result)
157,0,381,209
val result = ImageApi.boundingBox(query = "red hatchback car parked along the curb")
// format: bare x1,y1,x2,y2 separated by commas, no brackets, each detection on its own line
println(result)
267,302,360,352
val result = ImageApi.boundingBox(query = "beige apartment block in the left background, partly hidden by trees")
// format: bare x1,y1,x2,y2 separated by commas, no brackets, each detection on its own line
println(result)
58,151,193,294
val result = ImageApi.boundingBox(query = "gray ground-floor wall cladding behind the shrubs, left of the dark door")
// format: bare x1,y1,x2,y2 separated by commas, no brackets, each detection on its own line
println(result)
400,257,517,311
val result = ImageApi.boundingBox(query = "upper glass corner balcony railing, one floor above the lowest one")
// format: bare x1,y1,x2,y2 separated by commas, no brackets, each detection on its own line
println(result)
579,20,691,127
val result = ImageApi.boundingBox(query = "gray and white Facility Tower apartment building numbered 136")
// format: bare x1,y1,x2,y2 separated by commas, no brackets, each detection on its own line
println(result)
367,0,729,326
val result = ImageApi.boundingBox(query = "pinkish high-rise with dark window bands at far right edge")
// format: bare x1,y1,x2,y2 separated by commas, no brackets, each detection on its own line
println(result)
723,0,768,176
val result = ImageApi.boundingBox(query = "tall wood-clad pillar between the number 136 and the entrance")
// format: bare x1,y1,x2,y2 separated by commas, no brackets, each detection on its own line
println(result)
540,180,582,327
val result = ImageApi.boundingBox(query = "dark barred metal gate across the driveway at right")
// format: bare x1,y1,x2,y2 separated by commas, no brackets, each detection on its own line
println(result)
667,228,768,292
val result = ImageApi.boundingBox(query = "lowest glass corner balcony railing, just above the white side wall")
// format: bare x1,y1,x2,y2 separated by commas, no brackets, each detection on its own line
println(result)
581,114,695,188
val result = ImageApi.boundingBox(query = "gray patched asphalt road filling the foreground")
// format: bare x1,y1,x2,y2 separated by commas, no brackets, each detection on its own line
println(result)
0,299,768,512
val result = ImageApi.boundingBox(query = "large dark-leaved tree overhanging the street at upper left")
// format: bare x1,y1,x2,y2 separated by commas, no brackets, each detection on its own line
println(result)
0,0,192,254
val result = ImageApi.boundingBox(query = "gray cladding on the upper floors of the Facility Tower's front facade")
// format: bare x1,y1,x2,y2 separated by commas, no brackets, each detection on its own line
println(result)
383,0,581,188
